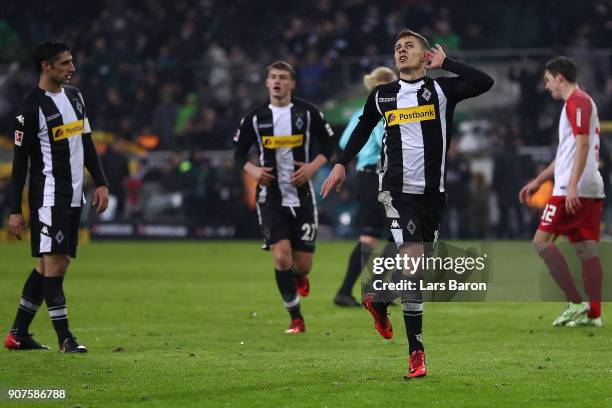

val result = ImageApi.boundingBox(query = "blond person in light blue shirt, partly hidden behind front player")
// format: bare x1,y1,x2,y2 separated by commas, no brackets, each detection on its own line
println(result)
334,67,397,307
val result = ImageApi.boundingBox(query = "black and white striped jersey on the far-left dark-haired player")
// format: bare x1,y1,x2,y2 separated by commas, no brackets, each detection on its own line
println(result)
11,86,108,214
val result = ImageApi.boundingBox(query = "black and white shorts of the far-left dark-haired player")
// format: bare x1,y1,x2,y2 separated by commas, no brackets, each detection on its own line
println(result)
30,207,81,258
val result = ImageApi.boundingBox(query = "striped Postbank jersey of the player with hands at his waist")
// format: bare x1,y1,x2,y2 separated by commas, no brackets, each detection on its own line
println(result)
234,98,335,207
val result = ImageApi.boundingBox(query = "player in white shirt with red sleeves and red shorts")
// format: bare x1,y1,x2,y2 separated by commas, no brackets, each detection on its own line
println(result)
519,57,605,327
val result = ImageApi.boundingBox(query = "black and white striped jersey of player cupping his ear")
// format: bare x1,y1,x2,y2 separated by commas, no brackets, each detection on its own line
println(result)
338,58,493,194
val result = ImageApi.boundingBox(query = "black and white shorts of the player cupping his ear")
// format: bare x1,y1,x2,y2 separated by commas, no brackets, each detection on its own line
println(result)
378,191,446,246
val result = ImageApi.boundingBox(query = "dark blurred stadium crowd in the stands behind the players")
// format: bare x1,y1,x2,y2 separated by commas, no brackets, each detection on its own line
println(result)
0,0,612,238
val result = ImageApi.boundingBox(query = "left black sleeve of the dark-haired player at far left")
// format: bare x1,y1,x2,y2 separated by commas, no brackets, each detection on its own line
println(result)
9,103,39,214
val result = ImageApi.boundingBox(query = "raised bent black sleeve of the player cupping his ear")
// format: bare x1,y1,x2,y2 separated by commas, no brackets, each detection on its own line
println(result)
436,57,494,102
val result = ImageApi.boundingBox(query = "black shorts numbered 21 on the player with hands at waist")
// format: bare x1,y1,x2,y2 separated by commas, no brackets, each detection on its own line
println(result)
257,204,319,253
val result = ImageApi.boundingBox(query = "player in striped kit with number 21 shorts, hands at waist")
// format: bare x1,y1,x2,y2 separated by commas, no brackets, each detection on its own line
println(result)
235,61,334,334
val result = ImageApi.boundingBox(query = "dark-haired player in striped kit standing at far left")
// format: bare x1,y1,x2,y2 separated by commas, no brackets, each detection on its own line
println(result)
4,41,108,353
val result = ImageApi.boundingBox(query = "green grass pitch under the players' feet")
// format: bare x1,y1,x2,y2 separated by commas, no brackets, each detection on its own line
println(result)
0,242,612,407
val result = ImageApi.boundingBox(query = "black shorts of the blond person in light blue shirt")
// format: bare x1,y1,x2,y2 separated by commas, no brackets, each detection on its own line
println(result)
357,169,387,238
